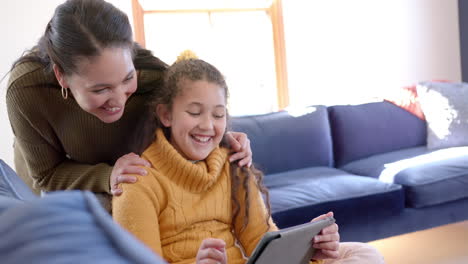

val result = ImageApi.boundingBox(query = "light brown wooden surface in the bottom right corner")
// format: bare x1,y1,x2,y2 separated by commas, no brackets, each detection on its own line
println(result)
369,221,468,264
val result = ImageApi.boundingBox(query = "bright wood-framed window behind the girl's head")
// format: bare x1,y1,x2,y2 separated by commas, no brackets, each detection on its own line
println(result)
135,0,286,115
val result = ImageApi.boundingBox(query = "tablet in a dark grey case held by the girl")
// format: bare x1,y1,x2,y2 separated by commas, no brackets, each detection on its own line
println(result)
247,217,335,264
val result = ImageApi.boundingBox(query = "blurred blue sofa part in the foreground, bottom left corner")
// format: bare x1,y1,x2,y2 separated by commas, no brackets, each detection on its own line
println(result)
0,191,164,264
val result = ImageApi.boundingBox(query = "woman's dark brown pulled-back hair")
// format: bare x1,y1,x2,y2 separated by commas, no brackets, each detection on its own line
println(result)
12,0,166,75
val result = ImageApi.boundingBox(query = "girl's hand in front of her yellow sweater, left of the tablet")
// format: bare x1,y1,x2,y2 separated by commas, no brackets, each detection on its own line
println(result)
197,238,227,264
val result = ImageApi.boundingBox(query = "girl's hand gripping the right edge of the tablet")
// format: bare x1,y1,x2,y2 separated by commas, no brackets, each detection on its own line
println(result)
312,212,340,260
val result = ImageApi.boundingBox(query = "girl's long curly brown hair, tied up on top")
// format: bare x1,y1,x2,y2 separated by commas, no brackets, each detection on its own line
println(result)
133,59,271,231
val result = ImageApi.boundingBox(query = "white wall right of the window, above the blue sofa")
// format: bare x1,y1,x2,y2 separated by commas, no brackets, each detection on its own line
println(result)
283,0,461,105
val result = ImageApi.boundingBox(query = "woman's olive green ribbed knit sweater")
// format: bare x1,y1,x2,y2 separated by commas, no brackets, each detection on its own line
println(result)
6,62,163,193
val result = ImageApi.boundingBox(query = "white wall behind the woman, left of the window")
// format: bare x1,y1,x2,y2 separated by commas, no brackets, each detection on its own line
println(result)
0,0,133,167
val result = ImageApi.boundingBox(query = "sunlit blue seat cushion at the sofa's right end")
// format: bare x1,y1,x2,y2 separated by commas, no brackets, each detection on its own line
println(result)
341,147,468,208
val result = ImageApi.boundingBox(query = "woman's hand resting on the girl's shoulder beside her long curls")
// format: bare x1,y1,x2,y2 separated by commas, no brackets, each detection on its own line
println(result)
226,132,252,167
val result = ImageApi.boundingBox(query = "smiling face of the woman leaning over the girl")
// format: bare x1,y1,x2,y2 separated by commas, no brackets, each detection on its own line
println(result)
54,48,137,123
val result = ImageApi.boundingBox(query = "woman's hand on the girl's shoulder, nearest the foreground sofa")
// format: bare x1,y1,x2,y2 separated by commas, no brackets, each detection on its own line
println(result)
110,153,151,196
